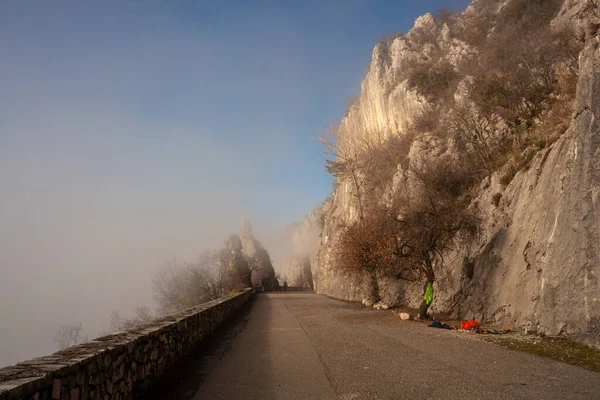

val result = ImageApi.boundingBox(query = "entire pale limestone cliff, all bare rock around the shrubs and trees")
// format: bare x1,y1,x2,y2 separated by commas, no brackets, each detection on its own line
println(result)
298,0,600,346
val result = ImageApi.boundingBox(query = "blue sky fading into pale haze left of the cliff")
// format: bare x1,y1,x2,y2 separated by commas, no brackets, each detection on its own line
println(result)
0,0,468,365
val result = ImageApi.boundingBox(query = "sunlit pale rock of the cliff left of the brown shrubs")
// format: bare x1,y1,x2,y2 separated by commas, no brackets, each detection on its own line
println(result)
313,5,475,307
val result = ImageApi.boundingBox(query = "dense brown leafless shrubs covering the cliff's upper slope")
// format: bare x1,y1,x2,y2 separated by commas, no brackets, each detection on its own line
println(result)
398,0,581,174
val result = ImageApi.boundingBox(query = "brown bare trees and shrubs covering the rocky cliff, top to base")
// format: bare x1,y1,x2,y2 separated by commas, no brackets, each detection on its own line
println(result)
321,0,582,317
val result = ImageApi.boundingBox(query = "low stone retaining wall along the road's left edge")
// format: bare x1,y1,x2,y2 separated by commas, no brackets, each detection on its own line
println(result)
0,289,254,400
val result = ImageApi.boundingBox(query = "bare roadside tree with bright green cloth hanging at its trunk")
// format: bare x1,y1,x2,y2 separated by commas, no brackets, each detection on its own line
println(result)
392,158,479,318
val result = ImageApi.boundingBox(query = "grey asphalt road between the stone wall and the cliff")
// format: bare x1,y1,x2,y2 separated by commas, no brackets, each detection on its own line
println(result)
148,293,600,400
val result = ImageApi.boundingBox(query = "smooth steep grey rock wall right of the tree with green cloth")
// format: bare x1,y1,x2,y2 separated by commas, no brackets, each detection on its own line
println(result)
459,19,600,346
